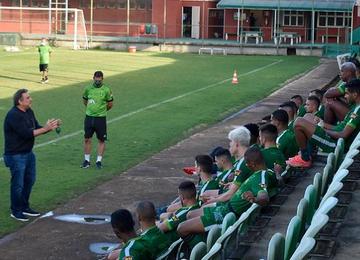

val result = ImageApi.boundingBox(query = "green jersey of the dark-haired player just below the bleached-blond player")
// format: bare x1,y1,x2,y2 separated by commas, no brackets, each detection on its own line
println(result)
228,170,273,215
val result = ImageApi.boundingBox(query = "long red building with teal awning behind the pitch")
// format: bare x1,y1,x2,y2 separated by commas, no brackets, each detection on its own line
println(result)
0,0,360,44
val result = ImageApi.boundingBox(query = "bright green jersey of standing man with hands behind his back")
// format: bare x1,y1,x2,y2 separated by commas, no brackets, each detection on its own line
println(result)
83,84,113,117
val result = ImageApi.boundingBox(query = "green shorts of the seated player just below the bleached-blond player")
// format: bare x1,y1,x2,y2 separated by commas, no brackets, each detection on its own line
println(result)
200,204,230,231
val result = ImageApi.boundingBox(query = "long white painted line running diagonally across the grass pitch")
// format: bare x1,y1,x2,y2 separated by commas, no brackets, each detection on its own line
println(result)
0,60,283,161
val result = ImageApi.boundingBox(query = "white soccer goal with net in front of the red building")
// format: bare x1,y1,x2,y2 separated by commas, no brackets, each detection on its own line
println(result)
0,6,89,49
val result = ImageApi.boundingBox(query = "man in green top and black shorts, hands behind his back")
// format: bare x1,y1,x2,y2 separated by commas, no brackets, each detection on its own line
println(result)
81,71,113,169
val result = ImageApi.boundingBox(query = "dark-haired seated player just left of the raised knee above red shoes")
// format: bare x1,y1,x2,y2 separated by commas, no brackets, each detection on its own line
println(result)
271,109,299,160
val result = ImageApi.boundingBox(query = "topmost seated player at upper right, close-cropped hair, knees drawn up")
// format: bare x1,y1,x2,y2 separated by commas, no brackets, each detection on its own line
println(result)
324,62,356,124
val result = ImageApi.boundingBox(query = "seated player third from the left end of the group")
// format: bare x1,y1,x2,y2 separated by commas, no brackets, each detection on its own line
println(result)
158,181,200,242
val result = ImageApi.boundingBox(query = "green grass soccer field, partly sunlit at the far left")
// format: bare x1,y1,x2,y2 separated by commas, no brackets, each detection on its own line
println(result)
0,48,318,236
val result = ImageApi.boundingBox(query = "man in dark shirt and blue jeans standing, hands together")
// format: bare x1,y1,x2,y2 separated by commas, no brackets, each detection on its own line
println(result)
4,89,60,221
